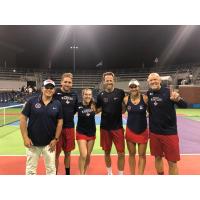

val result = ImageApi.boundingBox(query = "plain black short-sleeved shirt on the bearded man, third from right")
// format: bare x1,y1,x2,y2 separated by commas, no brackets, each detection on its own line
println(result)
97,88,125,130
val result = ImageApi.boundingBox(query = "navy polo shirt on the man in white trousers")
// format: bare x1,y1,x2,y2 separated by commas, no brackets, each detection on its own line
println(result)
22,96,63,146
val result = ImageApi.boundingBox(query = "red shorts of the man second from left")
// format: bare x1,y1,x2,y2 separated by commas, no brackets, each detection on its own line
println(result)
56,128,75,155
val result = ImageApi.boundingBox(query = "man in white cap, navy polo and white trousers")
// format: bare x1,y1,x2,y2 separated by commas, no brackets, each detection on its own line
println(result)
20,79,63,175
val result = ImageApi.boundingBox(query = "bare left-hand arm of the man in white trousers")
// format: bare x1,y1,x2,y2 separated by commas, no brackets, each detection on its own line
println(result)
20,114,33,148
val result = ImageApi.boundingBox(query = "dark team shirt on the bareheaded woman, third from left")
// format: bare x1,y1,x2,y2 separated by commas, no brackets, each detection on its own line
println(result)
76,102,96,137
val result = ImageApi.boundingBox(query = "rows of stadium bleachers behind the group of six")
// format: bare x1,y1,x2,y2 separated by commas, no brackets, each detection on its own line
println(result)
0,64,200,103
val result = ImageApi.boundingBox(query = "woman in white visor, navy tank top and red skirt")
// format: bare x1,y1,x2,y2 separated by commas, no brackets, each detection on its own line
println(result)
124,79,148,175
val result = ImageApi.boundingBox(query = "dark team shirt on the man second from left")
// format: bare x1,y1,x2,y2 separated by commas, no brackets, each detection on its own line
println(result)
54,88,78,128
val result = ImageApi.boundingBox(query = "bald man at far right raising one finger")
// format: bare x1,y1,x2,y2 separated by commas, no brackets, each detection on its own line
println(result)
147,73,187,175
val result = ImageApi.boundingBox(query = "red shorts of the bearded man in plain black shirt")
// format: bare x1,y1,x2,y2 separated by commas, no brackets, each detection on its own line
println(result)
100,128,125,153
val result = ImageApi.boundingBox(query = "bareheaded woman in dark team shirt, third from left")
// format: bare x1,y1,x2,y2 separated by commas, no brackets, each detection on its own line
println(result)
76,88,96,175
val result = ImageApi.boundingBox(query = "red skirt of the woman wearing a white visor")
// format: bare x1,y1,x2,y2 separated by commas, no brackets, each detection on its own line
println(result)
125,127,149,144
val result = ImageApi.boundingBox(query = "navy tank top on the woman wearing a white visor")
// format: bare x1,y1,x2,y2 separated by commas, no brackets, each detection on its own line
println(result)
126,95,147,134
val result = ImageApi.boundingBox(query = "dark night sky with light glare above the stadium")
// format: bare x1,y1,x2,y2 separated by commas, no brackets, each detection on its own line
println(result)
0,25,200,69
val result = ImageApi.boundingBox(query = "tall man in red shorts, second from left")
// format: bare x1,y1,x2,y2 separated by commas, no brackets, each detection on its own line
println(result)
55,73,78,175
